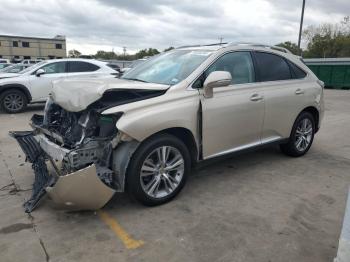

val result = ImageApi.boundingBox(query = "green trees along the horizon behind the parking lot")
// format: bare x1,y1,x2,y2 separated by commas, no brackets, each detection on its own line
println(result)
68,16,350,60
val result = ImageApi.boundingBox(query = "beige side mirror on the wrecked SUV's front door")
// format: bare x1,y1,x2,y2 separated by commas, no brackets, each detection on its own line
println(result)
203,71,232,98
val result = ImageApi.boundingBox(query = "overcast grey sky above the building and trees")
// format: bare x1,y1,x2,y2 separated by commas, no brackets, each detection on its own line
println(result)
0,0,350,54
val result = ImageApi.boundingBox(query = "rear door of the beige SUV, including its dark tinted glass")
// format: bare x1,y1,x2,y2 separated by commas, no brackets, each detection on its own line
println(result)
254,51,314,143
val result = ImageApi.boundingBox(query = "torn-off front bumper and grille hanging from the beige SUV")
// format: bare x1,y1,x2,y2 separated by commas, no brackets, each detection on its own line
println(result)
10,131,116,213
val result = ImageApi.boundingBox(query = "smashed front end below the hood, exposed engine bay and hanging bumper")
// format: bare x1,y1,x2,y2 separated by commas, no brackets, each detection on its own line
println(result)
10,90,164,212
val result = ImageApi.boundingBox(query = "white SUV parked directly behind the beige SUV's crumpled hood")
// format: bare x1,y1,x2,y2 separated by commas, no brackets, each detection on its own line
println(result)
0,58,118,113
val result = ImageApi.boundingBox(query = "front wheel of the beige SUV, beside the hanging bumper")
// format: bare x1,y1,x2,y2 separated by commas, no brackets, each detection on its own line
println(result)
127,134,191,206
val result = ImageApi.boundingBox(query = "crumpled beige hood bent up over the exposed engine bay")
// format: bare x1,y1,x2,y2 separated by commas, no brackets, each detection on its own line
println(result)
51,78,169,112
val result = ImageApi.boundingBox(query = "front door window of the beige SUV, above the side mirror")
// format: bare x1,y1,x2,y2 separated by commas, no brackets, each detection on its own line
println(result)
205,52,255,84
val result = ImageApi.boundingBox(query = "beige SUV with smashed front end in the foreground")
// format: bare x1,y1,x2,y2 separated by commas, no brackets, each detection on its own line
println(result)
11,44,324,212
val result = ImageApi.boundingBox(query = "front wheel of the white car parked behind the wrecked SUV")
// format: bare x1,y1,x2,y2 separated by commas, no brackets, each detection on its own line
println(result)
0,89,28,114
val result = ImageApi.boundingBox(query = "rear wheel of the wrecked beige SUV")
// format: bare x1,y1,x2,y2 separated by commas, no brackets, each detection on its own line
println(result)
280,112,315,157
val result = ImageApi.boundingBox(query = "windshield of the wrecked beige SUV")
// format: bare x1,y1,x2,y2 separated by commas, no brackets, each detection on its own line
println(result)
122,50,211,85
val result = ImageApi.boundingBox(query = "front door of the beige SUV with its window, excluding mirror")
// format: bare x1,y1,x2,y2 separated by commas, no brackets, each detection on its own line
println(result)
201,51,264,158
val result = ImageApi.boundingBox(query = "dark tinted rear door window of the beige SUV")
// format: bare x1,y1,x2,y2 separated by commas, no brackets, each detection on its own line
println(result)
255,52,293,82
